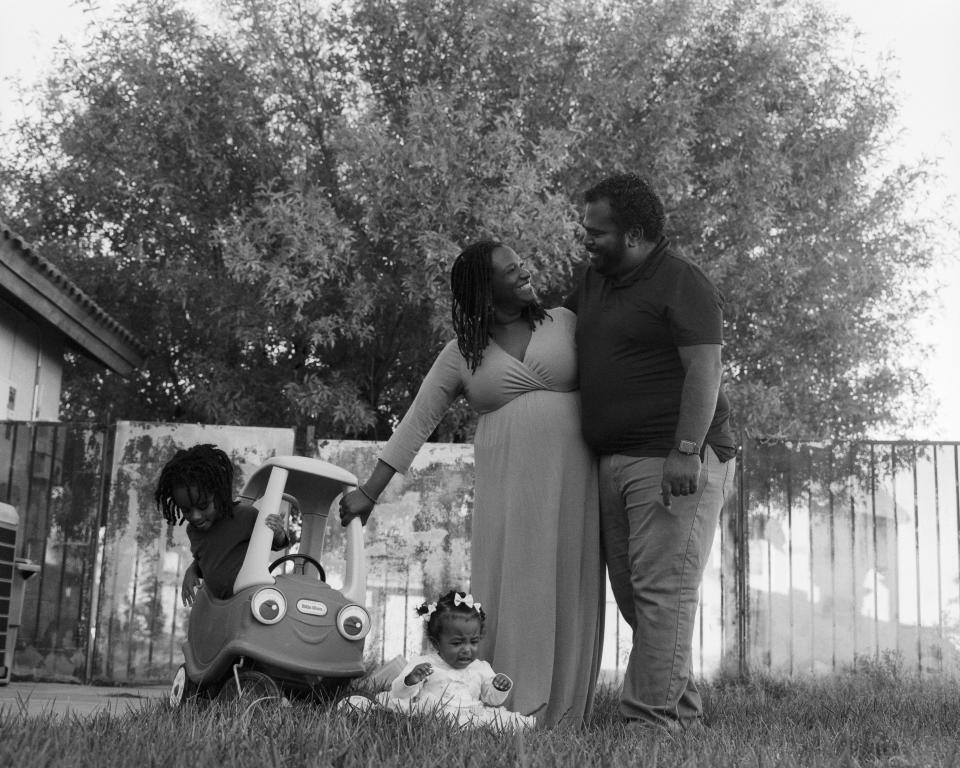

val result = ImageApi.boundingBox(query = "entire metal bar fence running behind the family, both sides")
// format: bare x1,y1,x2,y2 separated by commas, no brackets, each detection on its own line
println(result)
0,422,960,682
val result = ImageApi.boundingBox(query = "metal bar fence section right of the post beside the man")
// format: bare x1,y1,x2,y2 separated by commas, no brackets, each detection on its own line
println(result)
741,442,960,674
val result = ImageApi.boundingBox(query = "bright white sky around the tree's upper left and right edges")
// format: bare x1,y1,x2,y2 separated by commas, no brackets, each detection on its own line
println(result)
0,0,960,441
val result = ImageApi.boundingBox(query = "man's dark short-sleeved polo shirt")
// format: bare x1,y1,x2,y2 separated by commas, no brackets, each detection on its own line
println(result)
564,238,736,461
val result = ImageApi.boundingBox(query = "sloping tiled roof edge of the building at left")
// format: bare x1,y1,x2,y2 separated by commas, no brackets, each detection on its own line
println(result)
0,221,146,376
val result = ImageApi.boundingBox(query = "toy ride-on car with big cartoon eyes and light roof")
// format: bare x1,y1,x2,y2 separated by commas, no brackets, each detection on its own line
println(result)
170,456,370,706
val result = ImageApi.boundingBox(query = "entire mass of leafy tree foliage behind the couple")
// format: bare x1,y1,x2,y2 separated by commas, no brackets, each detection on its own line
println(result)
0,0,933,439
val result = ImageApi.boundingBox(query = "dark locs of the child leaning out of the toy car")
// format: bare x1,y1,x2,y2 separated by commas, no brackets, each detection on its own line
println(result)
153,443,233,525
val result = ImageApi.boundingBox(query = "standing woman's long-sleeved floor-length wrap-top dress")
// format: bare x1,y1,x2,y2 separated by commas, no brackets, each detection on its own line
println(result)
380,307,604,726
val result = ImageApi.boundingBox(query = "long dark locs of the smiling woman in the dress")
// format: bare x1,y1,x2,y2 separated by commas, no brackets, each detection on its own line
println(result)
450,240,546,373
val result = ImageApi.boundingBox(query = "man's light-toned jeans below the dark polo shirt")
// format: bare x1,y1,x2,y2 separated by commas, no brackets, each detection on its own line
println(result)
600,446,736,729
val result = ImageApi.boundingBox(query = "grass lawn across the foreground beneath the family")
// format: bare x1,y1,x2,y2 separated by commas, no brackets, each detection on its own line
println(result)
0,665,960,768
